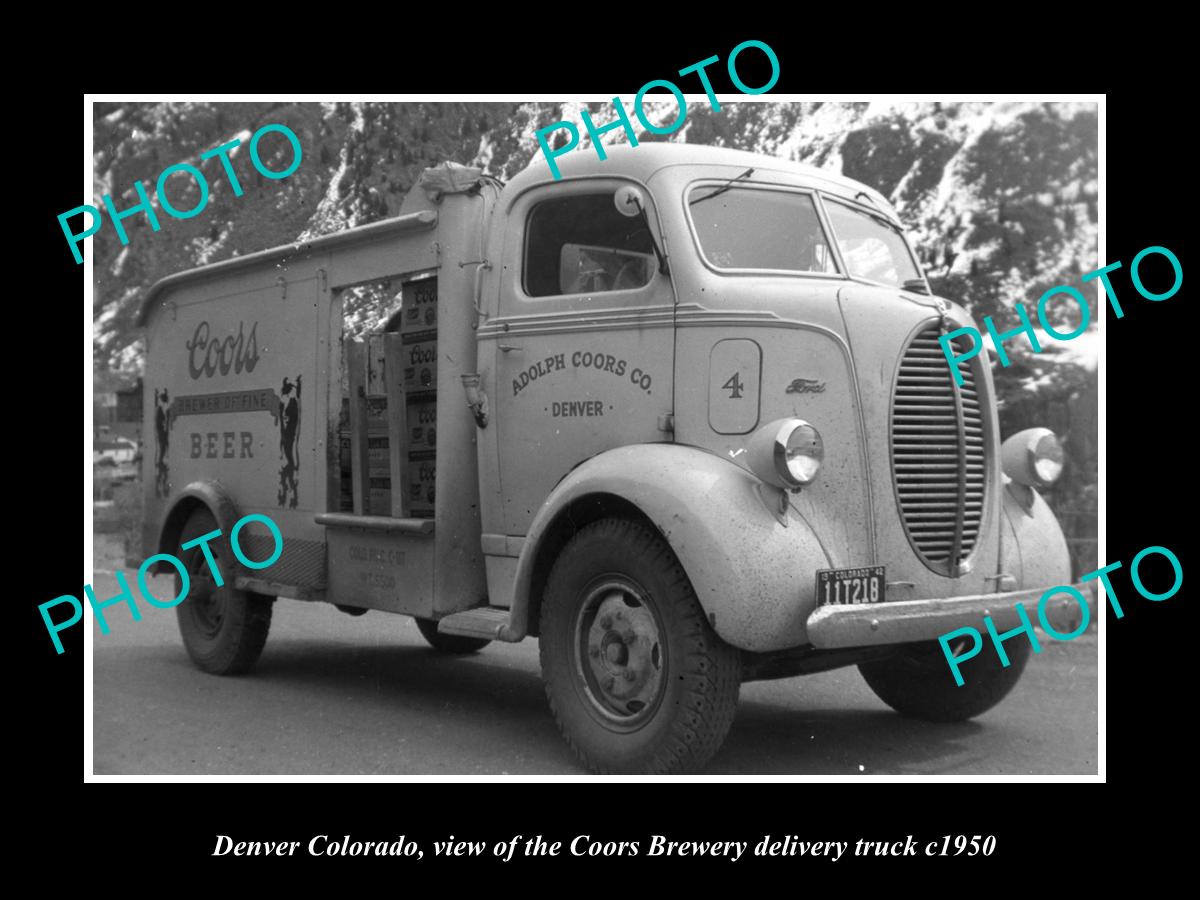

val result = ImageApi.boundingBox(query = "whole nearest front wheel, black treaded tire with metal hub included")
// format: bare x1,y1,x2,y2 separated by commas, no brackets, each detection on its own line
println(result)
540,518,740,774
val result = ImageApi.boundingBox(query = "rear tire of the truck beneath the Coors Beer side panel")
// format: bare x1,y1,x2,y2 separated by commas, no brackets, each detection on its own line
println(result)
175,508,275,676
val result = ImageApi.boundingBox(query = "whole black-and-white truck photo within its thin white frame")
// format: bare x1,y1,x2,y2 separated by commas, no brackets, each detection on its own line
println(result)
82,97,1099,780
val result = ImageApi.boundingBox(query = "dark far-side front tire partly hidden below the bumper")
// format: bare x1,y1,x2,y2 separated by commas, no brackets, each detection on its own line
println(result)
858,640,1030,722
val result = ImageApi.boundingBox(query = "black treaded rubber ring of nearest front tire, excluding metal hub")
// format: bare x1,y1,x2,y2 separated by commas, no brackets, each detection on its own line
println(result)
539,518,742,774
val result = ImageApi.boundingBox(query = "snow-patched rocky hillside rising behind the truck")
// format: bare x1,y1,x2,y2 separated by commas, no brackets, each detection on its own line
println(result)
91,98,1106,571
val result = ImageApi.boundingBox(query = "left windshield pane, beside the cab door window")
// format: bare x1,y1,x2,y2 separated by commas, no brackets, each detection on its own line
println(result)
688,185,836,272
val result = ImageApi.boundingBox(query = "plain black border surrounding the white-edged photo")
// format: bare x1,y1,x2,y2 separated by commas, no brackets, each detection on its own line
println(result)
21,19,1196,893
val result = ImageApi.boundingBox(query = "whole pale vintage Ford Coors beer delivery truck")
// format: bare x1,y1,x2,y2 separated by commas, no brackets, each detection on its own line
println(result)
140,144,1070,773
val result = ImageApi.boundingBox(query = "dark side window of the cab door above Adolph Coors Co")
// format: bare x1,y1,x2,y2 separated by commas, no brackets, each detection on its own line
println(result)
522,191,654,296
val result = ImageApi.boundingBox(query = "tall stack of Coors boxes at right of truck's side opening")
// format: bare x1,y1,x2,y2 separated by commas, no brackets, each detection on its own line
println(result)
400,278,438,518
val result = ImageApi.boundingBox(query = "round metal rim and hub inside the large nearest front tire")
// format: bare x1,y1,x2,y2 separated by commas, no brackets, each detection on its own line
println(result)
575,578,666,726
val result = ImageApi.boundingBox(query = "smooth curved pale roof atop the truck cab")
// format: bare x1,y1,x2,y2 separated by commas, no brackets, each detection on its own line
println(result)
504,140,899,221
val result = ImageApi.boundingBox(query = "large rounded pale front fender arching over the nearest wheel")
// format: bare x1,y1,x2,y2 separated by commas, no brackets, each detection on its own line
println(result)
512,444,830,652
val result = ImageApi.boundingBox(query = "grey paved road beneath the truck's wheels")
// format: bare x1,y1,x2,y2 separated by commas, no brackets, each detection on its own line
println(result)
92,572,1097,775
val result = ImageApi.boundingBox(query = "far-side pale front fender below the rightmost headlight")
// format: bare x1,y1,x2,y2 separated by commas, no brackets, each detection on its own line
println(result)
1000,479,1070,588
